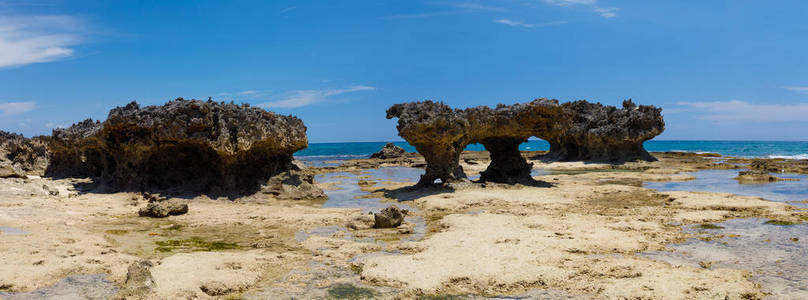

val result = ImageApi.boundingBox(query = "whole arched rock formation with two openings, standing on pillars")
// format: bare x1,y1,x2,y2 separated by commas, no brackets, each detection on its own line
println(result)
387,99,665,186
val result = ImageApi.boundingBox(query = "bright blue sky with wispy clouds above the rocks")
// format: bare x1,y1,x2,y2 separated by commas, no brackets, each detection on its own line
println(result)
0,0,808,142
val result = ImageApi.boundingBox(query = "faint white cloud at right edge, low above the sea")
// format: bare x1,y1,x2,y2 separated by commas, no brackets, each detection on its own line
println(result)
678,100,808,122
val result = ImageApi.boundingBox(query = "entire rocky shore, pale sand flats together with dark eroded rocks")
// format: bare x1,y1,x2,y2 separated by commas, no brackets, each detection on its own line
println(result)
0,99,808,299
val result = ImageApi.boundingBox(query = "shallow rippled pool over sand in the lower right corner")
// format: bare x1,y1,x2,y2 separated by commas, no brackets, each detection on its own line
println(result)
641,219,808,299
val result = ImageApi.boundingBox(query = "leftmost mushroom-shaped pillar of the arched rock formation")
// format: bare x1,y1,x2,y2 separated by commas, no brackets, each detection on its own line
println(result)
387,100,469,186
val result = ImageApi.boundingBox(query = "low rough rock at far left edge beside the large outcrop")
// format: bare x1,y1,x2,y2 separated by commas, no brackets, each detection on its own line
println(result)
0,131,49,178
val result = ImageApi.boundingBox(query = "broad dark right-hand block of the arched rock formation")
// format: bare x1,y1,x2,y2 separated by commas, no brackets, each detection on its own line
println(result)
536,99,665,163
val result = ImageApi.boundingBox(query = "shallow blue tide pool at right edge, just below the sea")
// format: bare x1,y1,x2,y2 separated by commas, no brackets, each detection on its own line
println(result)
644,170,808,207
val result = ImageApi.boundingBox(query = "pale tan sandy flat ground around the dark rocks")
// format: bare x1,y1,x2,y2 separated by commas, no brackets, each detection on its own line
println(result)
0,153,808,299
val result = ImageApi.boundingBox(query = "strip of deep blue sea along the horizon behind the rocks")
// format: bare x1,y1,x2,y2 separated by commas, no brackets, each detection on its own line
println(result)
295,140,808,164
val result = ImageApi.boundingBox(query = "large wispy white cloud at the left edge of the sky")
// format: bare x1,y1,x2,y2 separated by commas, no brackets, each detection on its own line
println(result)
0,15,83,67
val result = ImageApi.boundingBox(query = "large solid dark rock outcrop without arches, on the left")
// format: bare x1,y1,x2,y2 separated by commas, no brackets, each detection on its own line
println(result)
48,98,316,193
